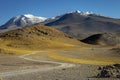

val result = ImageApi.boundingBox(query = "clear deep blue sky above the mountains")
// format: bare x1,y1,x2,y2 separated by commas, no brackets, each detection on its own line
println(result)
0,0,120,25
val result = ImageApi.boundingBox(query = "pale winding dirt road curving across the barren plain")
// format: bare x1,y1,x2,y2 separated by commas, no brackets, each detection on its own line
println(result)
0,52,75,77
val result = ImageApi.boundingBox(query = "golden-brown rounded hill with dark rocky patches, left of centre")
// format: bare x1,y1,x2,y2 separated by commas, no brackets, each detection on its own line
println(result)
0,24,84,53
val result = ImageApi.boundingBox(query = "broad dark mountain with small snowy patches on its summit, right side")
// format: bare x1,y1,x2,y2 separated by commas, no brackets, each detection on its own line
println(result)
44,11,120,38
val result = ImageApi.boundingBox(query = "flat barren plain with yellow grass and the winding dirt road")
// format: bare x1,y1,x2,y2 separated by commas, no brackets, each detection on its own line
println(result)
0,48,120,80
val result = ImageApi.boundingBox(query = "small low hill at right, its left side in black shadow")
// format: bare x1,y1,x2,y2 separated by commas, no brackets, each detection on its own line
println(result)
81,33,120,45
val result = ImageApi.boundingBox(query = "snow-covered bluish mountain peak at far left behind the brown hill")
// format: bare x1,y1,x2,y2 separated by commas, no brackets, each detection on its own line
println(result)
0,14,47,29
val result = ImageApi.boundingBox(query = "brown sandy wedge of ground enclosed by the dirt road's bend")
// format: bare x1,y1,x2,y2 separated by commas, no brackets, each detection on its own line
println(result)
0,56,57,73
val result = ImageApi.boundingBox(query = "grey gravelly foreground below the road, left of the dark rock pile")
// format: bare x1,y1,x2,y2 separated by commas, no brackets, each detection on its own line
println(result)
4,64,119,80
